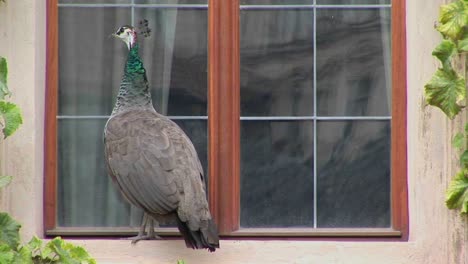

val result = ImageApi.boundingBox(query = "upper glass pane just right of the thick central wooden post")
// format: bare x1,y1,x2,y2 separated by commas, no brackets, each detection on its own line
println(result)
240,10,314,116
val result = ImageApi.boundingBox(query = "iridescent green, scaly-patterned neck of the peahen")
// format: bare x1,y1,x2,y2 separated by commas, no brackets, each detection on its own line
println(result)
112,44,154,115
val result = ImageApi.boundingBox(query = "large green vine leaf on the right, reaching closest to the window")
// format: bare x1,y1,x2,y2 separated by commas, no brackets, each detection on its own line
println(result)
424,68,466,119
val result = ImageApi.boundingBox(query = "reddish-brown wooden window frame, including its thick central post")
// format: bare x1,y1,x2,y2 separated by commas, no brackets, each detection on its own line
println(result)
44,0,409,241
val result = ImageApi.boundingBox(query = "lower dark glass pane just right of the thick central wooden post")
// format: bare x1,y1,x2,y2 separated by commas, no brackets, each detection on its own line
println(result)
240,121,314,227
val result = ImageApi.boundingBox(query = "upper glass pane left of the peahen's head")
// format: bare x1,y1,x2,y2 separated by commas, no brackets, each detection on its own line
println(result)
58,7,131,115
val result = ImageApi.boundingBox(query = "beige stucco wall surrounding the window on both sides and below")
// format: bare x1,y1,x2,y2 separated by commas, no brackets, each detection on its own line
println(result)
0,0,468,264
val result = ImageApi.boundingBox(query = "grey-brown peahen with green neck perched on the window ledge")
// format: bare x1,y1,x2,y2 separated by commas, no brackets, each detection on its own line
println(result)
104,26,219,252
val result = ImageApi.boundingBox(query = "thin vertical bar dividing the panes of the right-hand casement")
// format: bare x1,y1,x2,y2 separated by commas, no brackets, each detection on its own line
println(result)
312,0,317,228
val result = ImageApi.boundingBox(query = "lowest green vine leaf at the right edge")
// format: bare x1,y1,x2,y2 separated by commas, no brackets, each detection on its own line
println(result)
445,169,468,214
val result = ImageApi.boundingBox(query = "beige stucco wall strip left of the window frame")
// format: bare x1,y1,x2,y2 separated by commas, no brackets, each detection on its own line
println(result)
0,0,46,237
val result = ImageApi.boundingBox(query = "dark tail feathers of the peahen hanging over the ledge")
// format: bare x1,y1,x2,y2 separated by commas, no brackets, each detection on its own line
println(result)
177,217,219,252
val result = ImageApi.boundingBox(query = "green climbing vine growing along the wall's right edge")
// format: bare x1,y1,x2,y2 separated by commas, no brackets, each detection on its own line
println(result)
424,0,468,215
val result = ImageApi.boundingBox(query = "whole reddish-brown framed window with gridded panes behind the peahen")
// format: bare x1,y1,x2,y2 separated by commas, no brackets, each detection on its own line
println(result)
45,0,408,239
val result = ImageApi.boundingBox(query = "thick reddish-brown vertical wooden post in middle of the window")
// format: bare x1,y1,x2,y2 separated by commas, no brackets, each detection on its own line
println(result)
208,0,240,234
